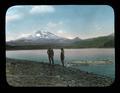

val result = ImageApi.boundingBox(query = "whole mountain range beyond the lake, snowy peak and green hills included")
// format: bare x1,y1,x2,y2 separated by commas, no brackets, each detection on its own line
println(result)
6,31,114,49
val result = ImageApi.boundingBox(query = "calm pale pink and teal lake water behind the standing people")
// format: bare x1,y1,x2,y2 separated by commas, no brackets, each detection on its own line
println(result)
6,48,115,79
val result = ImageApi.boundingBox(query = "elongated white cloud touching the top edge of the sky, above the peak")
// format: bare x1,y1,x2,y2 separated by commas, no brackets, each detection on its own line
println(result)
30,5,55,14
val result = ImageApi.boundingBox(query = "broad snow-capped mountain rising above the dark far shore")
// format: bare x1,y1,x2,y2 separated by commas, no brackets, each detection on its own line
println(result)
7,31,69,45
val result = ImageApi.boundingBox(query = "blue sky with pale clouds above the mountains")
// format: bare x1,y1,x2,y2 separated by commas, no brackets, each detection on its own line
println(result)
6,5,114,41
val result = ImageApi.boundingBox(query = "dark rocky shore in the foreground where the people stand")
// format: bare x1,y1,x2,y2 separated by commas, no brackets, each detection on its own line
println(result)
6,58,114,87
